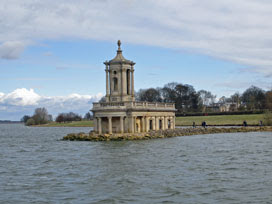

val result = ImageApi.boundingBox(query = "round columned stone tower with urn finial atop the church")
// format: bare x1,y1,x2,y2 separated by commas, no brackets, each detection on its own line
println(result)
104,40,135,102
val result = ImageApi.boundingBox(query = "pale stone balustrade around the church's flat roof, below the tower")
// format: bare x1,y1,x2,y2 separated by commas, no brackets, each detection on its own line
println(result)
93,101,175,109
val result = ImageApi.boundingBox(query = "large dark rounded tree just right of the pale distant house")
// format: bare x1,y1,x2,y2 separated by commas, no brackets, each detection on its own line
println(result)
242,86,265,110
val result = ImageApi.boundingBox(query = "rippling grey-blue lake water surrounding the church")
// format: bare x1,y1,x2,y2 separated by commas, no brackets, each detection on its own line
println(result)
0,124,272,203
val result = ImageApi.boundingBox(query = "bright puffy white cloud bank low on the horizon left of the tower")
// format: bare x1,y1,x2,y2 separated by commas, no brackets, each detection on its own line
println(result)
0,88,103,120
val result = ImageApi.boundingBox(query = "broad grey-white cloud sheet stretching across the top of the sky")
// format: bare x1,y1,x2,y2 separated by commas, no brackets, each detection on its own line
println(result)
0,0,272,76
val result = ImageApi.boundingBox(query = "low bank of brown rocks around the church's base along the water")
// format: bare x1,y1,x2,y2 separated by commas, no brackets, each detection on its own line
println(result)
63,126,272,141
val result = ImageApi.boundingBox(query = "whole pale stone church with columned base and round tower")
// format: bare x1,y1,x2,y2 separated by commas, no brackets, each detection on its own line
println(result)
92,40,176,134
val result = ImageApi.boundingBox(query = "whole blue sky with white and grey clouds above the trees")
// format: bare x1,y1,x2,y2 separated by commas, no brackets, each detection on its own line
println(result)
0,0,272,120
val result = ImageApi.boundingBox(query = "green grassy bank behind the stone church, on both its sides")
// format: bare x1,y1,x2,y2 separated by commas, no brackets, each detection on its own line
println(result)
34,114,264,127
